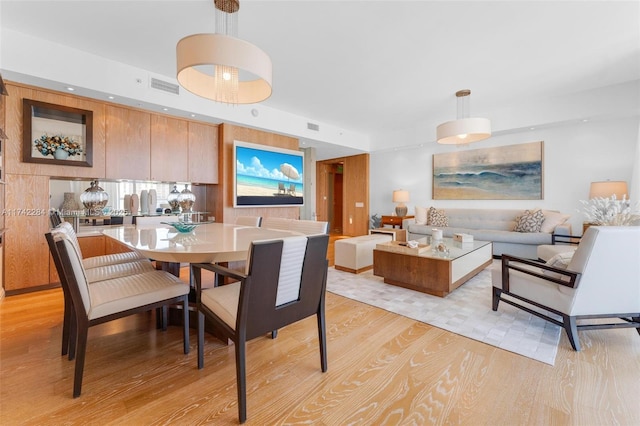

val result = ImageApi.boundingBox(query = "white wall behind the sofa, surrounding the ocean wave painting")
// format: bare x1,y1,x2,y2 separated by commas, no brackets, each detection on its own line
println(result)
370,116,640,235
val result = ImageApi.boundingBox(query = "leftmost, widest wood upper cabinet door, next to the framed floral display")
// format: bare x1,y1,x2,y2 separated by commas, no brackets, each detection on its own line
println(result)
105,105,151,180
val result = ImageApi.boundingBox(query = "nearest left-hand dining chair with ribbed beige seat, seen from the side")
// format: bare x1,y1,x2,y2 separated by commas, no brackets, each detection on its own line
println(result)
46,228,189,398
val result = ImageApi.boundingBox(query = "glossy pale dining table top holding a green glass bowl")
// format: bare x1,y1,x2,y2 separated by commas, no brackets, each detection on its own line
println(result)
103,223,302,263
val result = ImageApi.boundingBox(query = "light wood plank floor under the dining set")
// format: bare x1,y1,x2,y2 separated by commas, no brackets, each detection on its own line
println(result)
0,268,640,425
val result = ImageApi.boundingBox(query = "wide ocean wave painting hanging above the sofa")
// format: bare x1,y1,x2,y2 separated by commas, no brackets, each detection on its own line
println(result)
433,142,543,200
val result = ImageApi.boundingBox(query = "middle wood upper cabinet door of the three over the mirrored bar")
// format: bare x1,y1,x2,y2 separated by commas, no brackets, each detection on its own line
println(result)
151,114,189,182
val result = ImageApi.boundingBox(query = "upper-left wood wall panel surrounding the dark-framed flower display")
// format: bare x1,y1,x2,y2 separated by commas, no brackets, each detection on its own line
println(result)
5,83,105,178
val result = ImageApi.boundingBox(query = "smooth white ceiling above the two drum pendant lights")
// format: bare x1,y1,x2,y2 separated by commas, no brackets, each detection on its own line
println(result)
0,0,640,158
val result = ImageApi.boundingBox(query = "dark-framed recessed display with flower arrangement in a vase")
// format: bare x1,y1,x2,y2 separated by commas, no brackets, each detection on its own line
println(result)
22,99,93,167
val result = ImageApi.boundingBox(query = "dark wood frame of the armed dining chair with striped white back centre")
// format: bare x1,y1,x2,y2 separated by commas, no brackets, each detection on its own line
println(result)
191,235,329,423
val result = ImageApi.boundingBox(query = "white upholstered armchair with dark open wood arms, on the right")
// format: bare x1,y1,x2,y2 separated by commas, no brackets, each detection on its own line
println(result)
492,226,640,351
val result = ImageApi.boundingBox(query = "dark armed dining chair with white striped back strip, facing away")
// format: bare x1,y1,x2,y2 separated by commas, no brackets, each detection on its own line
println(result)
191,235,329,423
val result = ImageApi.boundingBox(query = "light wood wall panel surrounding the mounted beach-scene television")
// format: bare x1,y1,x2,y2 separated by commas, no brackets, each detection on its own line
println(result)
216,124,300,223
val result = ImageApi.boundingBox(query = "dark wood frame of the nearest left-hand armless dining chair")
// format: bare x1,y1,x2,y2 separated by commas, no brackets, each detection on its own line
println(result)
45,232,189,398
